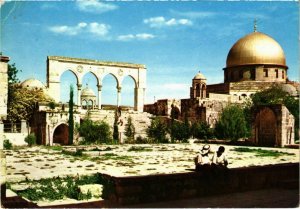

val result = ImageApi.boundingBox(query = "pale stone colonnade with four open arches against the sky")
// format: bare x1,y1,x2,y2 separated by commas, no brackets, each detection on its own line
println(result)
47,56,146,112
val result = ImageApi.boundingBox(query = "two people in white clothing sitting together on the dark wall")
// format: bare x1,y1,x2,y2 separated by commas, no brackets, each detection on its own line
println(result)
194,144,228,171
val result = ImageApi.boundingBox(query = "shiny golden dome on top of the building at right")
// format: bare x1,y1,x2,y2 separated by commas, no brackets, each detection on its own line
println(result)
226,32,287,68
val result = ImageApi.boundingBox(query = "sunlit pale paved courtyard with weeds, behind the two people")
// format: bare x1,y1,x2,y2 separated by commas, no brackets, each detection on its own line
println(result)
5,143,299,182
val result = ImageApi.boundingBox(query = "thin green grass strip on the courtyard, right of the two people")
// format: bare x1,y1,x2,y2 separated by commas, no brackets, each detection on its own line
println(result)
233,147,295,157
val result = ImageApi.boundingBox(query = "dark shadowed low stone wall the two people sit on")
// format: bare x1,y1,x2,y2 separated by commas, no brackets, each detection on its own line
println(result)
104,163,299,206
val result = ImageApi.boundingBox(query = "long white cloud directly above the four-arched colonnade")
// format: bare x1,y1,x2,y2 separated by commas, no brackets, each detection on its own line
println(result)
49,22,110,37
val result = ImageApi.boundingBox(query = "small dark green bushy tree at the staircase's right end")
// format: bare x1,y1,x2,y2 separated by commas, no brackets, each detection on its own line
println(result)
147,118,168,143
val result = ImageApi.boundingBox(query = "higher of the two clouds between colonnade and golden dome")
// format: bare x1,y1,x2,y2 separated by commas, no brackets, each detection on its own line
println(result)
144,16,193,28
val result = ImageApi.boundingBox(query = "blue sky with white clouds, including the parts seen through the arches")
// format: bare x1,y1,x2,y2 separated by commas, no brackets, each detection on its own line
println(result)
1,0,299,105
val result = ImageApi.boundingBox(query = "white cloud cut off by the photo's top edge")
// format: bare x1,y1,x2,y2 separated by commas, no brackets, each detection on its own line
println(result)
76,0,118,13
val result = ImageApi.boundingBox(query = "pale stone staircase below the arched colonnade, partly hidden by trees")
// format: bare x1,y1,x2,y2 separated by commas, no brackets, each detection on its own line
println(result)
80,110,153,138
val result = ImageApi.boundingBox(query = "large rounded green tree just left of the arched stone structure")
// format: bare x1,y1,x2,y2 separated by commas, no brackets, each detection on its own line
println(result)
215,105,249,141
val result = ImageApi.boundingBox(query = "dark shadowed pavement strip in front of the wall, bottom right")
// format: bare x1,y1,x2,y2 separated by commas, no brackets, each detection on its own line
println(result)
126,188,299,208
